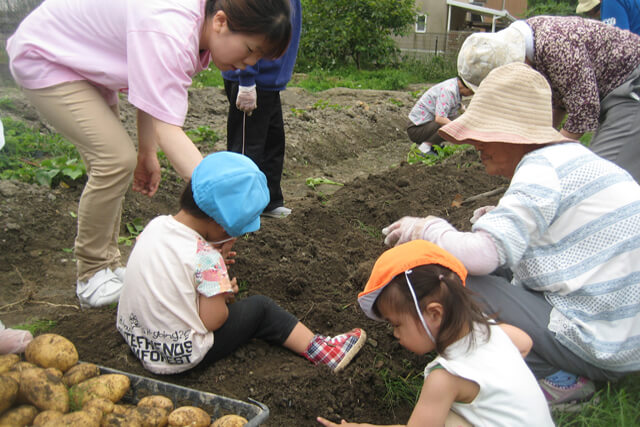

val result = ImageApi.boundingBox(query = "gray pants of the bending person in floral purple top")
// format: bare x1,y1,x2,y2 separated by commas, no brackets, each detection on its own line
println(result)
590,66,640,182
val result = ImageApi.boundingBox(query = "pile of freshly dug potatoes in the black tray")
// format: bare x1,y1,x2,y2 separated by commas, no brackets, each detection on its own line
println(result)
0,334,247,427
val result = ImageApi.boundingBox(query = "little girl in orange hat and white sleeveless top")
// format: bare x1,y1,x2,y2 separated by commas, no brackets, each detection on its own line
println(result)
318,240,553,427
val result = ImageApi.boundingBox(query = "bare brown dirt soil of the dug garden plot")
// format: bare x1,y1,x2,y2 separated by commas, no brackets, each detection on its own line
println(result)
0,83,506,426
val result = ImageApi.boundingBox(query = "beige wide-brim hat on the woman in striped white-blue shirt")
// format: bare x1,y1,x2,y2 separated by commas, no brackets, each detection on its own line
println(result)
438,62,571,144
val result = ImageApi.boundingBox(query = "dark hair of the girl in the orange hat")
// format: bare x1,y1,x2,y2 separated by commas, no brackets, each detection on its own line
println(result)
373,264,490,354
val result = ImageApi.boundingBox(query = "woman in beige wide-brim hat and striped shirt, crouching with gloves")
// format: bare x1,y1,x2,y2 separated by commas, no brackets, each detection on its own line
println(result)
383,62,640,412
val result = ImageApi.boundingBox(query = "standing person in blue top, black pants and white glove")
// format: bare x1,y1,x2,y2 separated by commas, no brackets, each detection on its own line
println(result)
222,0,302,218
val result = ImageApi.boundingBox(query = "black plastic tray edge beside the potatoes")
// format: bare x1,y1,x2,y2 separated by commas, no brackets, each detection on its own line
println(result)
100,366,269,427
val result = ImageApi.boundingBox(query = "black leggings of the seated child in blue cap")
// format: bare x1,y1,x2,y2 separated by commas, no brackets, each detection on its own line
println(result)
204,295,298,363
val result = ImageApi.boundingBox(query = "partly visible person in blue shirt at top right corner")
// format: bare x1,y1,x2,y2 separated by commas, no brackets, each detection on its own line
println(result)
576,0,640,35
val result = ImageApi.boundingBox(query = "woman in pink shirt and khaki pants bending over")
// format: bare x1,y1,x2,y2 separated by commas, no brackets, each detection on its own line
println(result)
7,0,291,307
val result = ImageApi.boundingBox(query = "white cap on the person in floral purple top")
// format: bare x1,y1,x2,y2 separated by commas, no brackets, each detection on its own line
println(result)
458,26,526,92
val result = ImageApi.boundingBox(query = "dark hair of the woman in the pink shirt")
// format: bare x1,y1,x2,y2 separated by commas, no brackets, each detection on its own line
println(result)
205,0,291,58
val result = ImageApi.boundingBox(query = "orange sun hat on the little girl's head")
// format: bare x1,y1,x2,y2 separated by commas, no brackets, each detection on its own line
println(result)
358,240,467,320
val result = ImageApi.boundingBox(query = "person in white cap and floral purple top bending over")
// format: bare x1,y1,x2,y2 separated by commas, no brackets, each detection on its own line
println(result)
458,16,640,180
